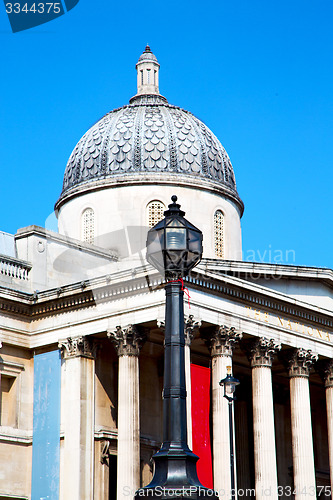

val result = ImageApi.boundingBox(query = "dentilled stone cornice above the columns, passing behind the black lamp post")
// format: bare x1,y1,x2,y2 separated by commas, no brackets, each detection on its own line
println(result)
0,266,333,334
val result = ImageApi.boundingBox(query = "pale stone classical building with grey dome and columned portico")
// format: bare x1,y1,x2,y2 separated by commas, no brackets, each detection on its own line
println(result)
0,46,333,500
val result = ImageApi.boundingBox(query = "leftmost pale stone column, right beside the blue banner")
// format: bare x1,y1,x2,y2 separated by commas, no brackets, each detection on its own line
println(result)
59,337,96,500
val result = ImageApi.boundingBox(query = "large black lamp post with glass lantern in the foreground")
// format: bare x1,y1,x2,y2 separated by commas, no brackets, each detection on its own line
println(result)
135,196,216,500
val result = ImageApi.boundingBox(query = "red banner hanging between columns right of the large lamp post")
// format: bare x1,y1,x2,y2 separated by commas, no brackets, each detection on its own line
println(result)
191,364,213,488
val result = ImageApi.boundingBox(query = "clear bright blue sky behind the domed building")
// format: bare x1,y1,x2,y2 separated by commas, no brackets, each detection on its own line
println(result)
0,0,333,268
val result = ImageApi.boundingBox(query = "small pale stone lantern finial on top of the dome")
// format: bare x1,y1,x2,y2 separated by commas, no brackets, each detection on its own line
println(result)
136,43,160,95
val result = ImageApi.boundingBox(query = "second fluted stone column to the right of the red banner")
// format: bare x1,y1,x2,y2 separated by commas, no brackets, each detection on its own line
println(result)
247,337,281,500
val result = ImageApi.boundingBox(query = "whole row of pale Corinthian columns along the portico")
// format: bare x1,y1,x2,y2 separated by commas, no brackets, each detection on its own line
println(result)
60,324,333,500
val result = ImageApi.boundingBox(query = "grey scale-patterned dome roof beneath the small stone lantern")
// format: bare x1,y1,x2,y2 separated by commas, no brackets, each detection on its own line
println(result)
56,95,243,212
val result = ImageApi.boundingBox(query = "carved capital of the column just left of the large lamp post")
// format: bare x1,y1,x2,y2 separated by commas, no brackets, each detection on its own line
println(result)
107,325,147,357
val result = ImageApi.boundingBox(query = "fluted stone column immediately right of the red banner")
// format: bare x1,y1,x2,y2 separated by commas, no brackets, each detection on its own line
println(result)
206,326,242,500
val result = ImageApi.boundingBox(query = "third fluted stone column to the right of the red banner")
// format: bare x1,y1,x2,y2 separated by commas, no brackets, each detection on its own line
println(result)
284,348,318,500
